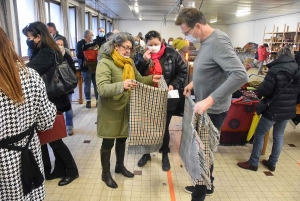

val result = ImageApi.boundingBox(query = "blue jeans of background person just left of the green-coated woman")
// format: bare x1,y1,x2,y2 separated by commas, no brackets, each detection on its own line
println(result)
81,71,98,101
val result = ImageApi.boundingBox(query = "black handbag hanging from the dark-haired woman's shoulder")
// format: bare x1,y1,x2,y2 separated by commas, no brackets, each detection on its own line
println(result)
41,51,77,98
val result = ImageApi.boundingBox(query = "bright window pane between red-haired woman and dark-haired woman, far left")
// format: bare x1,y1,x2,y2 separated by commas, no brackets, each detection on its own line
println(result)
17,0,35,57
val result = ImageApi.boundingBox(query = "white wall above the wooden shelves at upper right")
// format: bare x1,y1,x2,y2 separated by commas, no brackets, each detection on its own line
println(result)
228,13,300,47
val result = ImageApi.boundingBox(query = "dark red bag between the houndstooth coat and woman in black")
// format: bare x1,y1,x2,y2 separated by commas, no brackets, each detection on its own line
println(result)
38,112,67,145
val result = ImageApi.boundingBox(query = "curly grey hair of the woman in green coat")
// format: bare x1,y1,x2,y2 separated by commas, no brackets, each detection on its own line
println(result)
105,32,134,54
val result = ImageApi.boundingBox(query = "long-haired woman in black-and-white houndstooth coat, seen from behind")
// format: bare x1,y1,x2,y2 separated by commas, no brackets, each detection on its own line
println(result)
0,27,56,201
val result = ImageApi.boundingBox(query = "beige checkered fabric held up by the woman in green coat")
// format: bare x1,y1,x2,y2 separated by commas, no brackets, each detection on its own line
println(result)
128,78,168,154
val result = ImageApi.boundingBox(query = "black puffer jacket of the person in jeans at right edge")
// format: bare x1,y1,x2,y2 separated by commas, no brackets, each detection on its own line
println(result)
259,55,300,121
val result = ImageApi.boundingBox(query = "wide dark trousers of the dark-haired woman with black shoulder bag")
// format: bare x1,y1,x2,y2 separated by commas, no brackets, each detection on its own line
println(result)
42,139,78,177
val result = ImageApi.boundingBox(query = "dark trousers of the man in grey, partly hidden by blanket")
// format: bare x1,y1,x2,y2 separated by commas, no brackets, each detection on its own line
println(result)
192,112,227,201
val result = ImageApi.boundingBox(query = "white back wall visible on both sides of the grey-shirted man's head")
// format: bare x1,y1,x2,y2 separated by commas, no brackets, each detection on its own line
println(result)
114,20,227,41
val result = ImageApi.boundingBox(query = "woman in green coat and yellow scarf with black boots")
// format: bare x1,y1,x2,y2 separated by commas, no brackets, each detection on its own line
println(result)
96,32,161,188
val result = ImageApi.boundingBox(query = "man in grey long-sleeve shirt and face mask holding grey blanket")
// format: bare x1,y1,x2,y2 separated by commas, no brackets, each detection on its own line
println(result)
175,8,248,201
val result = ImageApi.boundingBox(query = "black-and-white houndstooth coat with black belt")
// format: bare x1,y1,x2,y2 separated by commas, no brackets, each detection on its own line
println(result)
0,68,56,201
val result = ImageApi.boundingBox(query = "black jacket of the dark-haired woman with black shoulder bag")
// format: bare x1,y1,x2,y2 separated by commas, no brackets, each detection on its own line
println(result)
26,47,71,112
